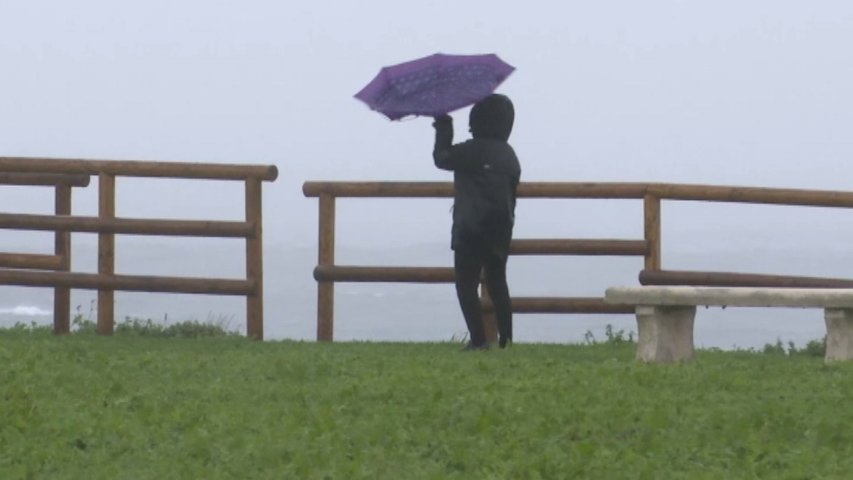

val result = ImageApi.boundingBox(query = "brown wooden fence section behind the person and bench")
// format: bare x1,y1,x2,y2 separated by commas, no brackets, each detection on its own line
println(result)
302,182,853,341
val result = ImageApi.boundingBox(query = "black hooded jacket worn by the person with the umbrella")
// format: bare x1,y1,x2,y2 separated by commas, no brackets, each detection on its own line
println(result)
433,94,521,257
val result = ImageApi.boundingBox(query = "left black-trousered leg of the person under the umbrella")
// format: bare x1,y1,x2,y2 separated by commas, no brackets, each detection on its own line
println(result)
453,248,486,347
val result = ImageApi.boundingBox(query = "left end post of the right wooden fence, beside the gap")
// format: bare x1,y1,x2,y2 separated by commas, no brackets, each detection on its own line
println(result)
317,193,335,342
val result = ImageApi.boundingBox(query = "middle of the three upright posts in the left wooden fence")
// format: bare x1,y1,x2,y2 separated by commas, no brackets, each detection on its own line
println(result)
98,173,116,335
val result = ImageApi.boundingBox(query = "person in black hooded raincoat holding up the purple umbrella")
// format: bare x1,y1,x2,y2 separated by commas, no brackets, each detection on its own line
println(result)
433,94,521,350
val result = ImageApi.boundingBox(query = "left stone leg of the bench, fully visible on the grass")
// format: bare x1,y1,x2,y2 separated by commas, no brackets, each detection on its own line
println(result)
636,305,696,362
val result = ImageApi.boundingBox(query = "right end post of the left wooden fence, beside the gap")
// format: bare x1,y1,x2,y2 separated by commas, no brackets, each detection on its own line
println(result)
246,178,264,340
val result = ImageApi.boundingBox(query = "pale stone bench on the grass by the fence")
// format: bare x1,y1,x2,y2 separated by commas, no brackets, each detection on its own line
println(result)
604,286,853,362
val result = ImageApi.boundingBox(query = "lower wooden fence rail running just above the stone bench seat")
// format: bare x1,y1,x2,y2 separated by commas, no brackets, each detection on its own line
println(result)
640,270,853,288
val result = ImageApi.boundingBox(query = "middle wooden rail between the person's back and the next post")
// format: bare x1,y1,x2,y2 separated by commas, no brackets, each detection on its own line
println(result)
509,239,649,256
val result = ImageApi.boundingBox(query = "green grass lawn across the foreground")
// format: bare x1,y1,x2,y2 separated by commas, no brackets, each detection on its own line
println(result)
0,331,853,479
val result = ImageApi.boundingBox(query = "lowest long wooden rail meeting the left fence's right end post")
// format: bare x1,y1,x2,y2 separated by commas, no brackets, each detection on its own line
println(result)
0,270,255,295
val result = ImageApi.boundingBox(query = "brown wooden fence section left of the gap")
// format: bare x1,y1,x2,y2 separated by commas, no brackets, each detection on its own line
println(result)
0,157,278,340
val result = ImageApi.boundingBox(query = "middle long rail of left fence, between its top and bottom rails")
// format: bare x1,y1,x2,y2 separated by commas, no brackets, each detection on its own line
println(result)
0,213,255,238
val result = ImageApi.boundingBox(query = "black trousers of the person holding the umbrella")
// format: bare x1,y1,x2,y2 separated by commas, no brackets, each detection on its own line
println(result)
453,244,512,346
